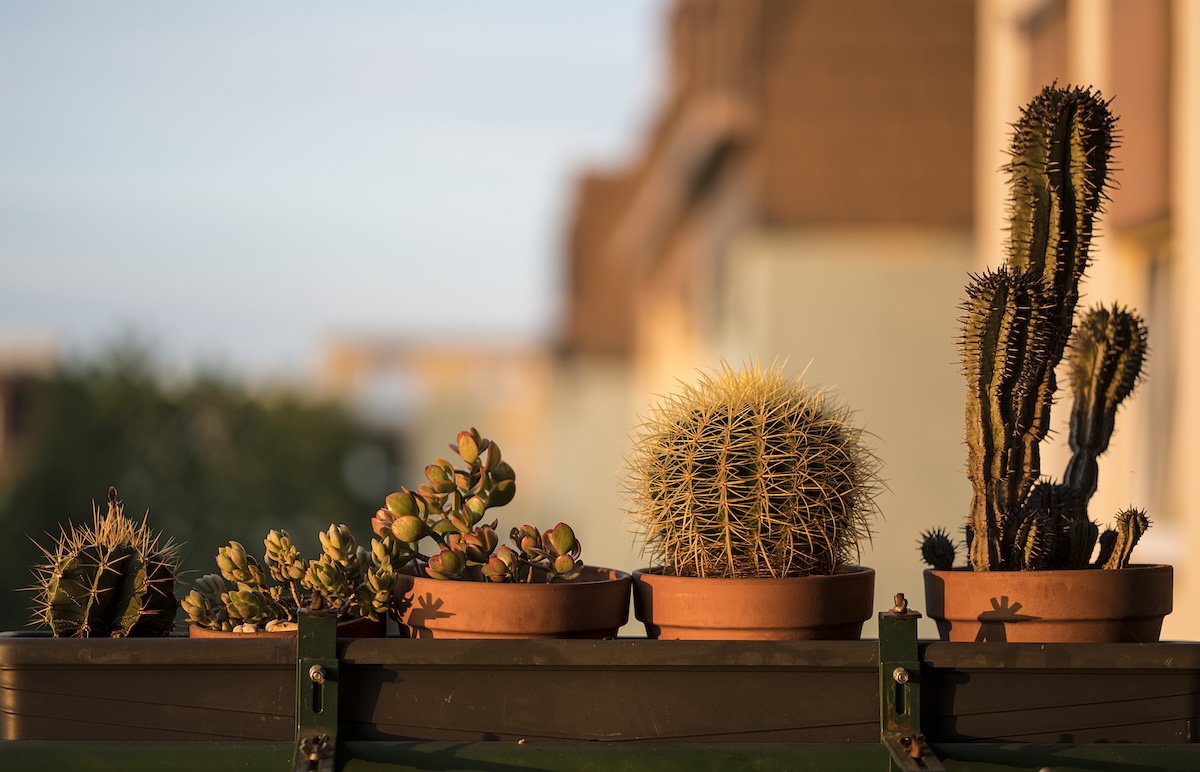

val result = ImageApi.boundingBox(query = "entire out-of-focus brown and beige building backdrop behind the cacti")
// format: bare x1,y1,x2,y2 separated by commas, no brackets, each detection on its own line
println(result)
329,0,1200,638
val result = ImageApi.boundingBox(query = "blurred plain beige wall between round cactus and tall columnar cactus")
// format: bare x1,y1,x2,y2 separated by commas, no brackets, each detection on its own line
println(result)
709,228,973,636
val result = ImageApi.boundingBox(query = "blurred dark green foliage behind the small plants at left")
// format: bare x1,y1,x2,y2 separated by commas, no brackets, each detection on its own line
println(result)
0,343,395,630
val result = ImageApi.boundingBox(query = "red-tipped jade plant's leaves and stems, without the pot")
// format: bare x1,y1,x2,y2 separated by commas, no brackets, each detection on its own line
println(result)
371,427,583,582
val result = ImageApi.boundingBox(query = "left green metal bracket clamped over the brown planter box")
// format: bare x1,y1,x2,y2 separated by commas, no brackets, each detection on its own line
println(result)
292,610,337,772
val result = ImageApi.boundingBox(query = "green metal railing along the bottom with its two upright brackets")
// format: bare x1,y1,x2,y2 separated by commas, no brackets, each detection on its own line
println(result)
0,596,1200,772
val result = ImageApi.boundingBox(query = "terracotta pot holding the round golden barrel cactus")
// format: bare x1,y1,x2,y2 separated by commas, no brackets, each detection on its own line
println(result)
634,565,875,640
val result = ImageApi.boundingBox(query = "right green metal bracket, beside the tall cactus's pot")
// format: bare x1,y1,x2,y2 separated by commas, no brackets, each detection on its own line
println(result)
880,593,946,771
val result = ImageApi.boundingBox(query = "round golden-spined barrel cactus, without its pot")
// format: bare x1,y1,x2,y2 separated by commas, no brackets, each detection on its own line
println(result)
626,363,881,577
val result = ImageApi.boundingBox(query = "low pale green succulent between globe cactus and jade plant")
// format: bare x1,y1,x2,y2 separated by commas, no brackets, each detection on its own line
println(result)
182,525,404,633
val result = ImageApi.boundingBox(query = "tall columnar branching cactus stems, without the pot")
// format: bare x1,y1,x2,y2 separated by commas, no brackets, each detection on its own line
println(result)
922,86,1148,571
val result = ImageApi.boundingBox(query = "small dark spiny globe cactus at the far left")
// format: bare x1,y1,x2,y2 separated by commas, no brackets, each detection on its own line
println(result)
30,487,179,638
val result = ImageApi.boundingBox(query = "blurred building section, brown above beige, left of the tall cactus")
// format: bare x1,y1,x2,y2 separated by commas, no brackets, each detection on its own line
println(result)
565,0,977,638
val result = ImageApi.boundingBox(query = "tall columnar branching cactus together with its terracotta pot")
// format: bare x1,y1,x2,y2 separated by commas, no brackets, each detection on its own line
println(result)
922,86,1171,641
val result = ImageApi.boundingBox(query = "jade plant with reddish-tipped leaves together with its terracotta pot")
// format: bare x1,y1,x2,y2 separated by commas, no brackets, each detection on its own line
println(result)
371,429,630,638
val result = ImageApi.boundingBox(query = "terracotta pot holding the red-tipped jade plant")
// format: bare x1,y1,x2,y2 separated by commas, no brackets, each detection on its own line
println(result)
395,565,631,639
